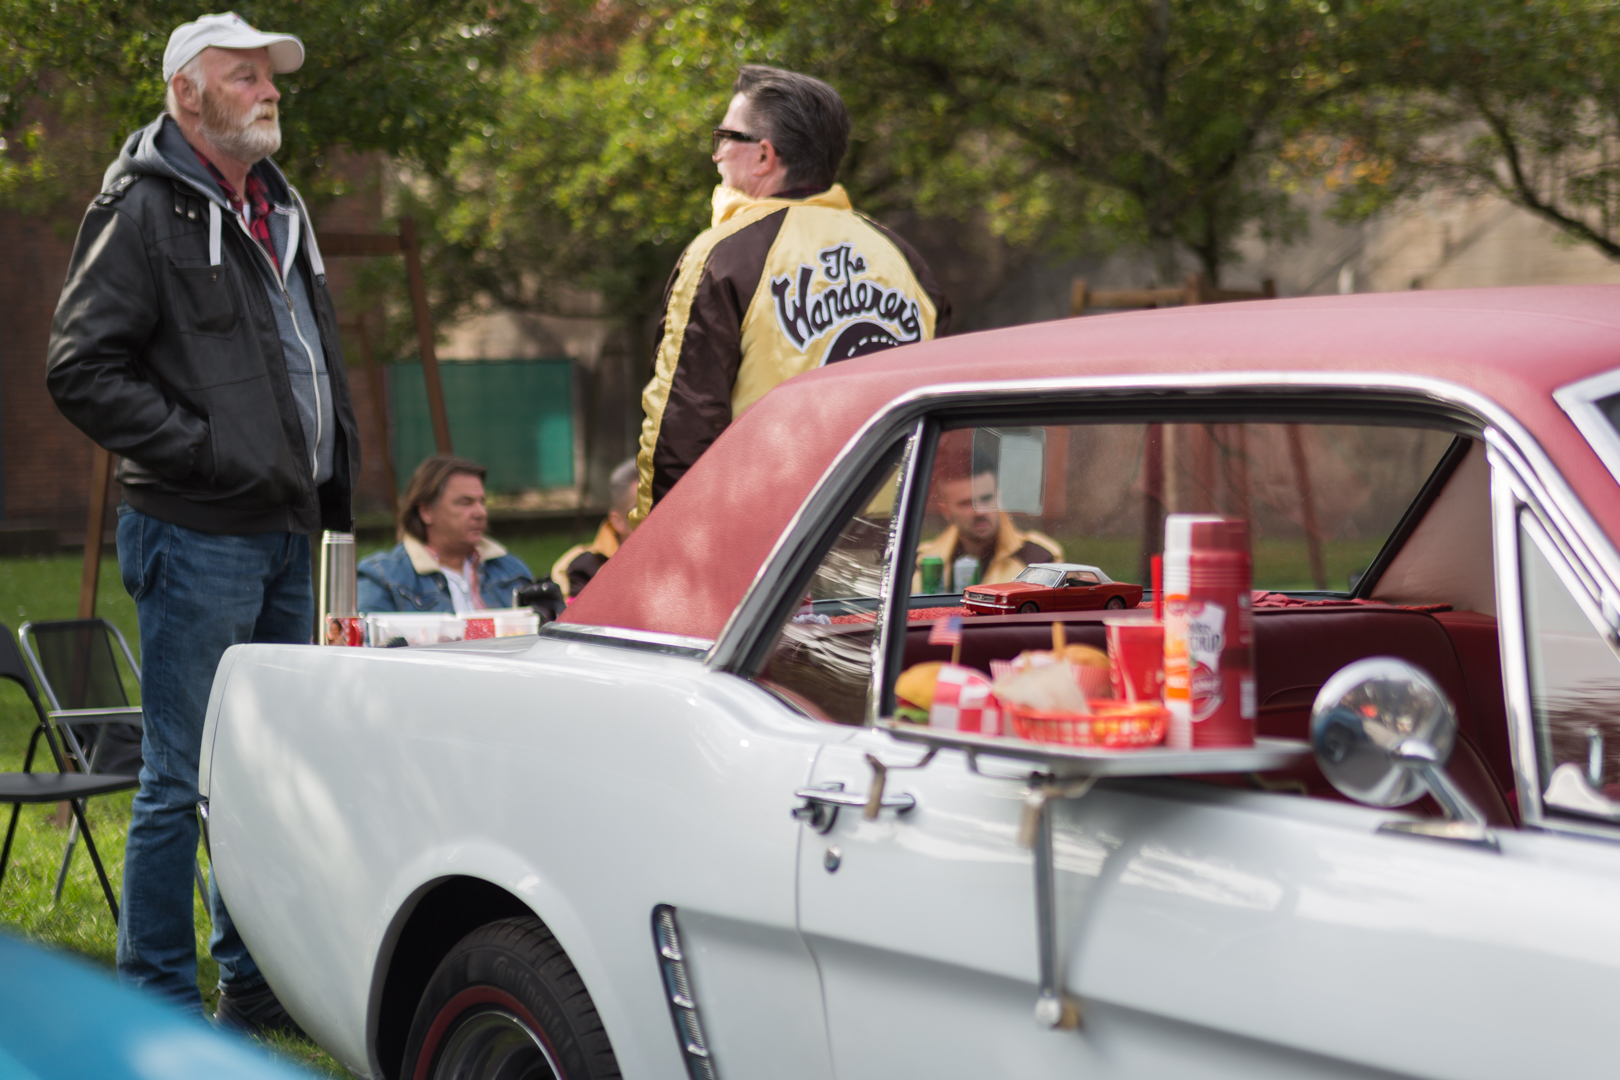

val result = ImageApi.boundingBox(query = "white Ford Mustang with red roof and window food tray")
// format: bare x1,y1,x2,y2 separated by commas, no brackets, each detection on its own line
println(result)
201,288,1620,1080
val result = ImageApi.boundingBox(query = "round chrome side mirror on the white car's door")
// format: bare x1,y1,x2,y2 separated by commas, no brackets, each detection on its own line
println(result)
1311,656,1497,848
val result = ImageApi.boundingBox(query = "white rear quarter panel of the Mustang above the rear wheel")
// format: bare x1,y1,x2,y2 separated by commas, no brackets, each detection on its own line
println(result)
206,638,826,1077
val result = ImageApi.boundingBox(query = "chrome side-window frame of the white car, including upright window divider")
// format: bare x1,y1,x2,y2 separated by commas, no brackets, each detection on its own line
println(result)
705,371,1620,751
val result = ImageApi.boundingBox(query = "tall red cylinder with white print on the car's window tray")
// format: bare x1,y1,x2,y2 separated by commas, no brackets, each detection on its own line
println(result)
1186,518,1257,746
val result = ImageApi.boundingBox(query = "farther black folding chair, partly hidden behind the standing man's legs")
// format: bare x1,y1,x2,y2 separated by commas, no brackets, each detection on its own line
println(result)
16,619,207,900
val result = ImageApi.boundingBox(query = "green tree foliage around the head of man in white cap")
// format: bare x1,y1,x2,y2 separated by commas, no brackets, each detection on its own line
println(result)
0,0,536,212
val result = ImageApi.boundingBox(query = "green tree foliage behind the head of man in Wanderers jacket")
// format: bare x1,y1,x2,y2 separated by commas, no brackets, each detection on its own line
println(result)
411,0,1346,362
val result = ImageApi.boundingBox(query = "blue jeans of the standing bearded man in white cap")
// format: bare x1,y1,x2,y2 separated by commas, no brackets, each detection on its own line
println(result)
118,505,314,1012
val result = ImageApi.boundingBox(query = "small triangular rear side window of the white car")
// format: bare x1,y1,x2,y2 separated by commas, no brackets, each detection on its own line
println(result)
758,447,902,724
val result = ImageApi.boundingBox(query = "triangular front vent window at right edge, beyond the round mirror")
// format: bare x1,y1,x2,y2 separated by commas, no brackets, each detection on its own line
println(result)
1520,512,1620,819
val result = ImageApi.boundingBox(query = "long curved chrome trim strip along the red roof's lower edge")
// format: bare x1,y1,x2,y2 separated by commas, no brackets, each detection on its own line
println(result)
708,371,1620,670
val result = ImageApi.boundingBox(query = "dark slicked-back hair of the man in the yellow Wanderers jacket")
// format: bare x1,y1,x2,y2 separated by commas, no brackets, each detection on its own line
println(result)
731,63,849,189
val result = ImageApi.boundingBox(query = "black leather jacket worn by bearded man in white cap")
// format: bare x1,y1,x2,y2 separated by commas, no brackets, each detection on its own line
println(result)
45,118,360,534
